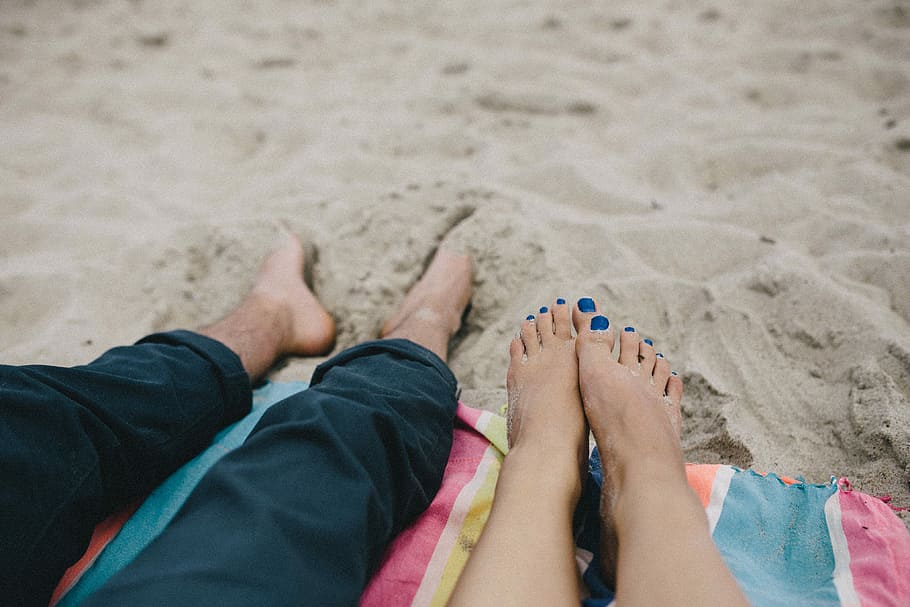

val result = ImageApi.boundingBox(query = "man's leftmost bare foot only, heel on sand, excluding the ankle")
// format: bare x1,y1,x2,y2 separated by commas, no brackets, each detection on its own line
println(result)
249,234,335,356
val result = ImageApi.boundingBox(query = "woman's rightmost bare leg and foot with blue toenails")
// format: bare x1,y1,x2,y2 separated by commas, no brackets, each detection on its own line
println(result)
574,302,748,605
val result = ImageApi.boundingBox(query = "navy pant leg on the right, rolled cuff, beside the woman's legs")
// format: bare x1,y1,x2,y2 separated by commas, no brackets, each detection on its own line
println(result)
88,340,457,607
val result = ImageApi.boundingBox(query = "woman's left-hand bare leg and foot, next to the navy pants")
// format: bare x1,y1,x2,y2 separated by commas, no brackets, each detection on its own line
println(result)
450,299,587,607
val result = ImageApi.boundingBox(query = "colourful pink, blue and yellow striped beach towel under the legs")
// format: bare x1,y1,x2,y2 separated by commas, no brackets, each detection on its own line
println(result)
52,383,910,607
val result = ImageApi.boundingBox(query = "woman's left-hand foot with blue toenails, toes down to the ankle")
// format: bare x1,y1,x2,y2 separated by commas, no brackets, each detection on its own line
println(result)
506,299,588,499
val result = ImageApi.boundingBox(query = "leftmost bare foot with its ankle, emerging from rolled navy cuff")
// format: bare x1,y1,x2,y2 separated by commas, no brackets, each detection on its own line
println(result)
200,234,335,381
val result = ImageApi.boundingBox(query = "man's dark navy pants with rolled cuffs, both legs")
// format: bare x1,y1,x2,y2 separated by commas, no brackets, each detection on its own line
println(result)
0,332,456,607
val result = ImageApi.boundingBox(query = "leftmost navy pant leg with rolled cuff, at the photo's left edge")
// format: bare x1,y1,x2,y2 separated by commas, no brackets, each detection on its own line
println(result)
0,331,251,607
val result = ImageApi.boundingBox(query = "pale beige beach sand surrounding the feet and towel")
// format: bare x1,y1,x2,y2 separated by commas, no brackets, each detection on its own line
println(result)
0,0,910,526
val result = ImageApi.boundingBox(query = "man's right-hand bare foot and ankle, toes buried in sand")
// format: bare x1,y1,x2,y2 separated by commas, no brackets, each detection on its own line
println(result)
380,243,472,360
